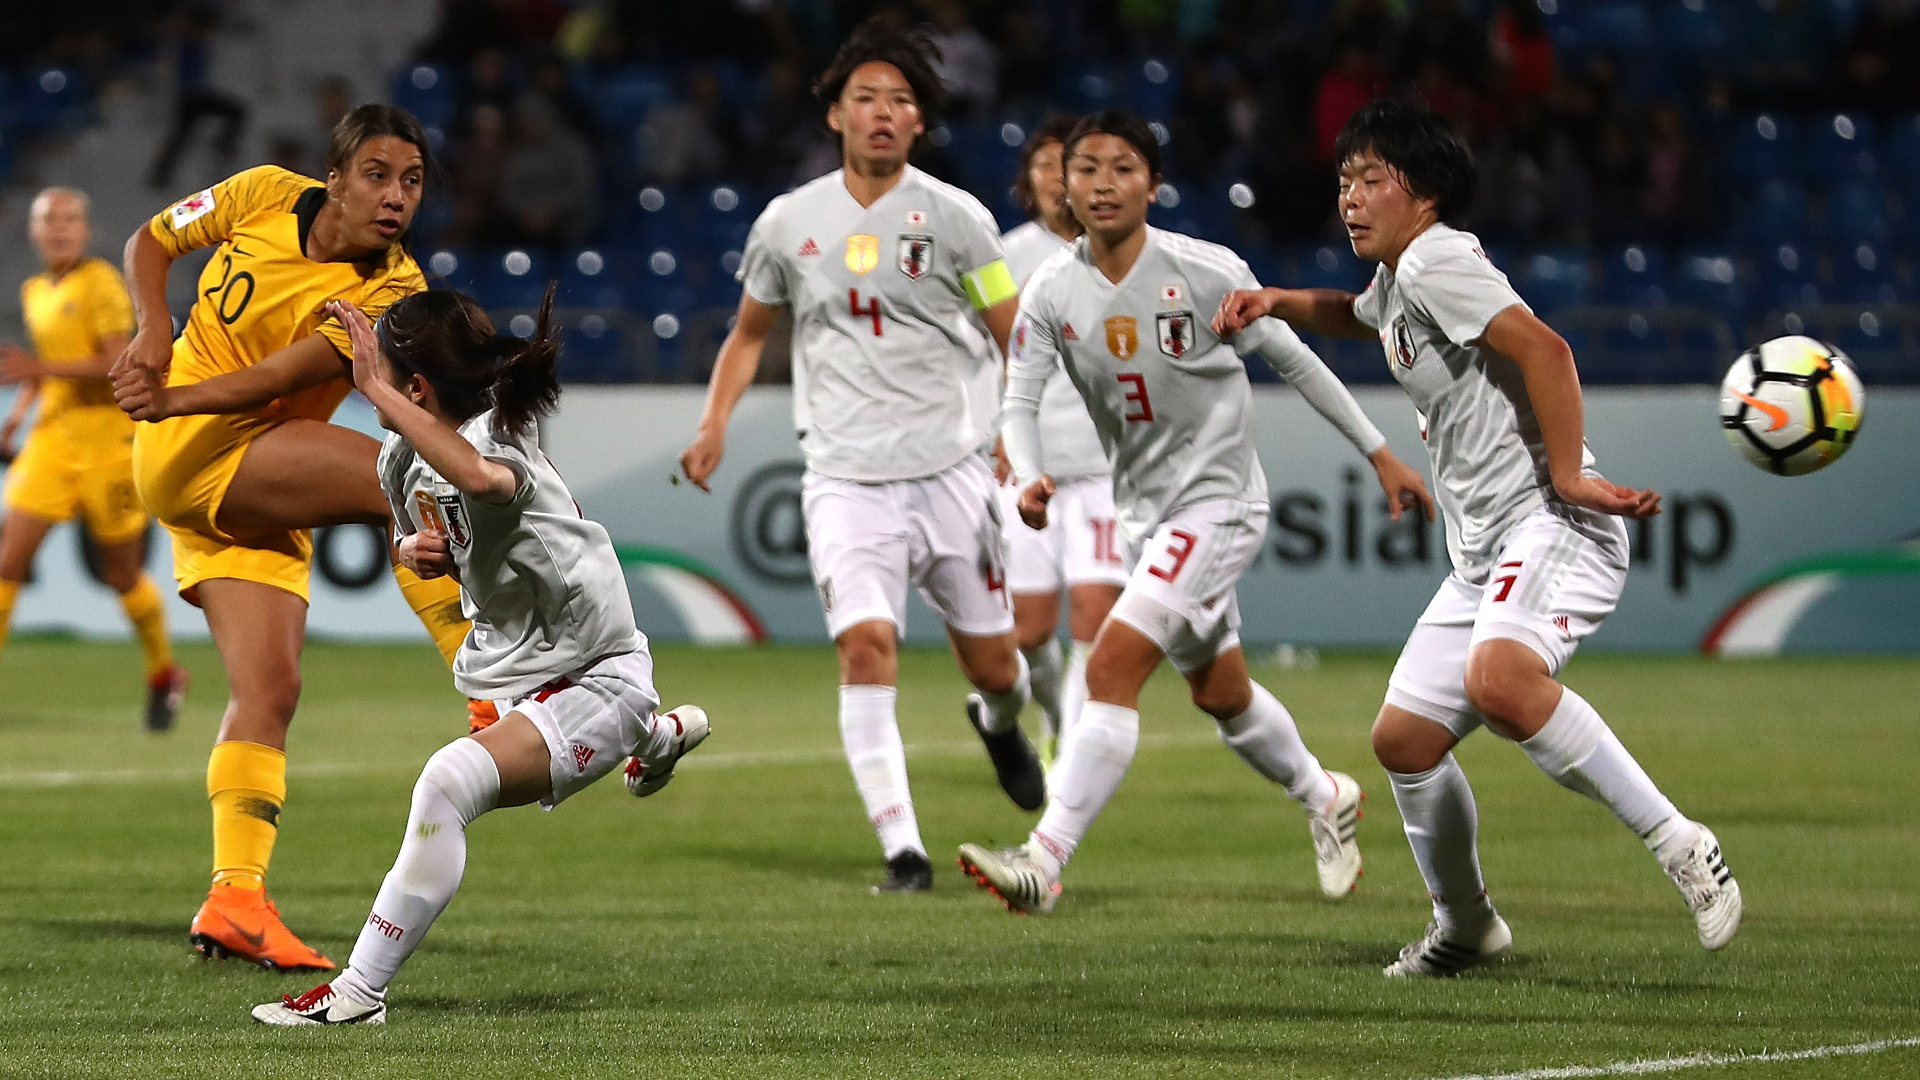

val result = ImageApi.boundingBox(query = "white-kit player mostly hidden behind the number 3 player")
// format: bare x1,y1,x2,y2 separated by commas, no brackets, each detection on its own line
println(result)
1000,117,1127,765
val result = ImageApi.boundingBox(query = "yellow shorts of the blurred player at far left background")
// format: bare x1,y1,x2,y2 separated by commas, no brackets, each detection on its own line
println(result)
6,407,146,544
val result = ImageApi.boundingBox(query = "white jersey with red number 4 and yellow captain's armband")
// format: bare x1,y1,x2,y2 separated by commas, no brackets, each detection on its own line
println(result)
739,165,1016,482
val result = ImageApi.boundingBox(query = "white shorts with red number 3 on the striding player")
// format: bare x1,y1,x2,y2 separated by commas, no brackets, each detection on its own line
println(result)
1112,500,1267,671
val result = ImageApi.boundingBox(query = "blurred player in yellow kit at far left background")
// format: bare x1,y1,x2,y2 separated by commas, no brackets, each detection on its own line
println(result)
0,188,186,732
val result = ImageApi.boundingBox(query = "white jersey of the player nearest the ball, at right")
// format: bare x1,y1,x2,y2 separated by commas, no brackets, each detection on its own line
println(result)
1354,225,1609,580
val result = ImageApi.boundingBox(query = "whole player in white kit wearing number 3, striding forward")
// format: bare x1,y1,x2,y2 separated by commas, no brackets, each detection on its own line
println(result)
960,111,1430,913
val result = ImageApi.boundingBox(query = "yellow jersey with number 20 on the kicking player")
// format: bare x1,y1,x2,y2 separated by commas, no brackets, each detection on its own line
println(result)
148,165,426,421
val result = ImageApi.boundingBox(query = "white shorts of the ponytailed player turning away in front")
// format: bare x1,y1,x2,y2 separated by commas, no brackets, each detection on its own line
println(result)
493,646,660,809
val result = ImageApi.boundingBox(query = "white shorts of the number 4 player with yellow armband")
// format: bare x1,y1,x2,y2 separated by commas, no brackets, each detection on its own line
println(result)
801,455,1014,638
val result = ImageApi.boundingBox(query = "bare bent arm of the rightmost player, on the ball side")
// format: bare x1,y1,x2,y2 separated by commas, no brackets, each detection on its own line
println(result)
1484,304,1661,517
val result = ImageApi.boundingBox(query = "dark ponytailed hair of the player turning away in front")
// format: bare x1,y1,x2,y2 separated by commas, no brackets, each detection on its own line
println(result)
374,282,561,438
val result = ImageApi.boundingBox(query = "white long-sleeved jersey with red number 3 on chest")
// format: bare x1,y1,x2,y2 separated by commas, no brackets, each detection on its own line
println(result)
1006,229,1384,550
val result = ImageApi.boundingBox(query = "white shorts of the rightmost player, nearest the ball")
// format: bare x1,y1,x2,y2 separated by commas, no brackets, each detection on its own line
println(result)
1386,507,1630,738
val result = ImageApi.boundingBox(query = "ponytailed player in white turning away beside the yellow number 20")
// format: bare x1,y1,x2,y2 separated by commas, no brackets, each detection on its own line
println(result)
253,286,707,1026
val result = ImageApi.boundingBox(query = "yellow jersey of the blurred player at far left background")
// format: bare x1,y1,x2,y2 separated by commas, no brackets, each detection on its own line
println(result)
19,259,132,417
